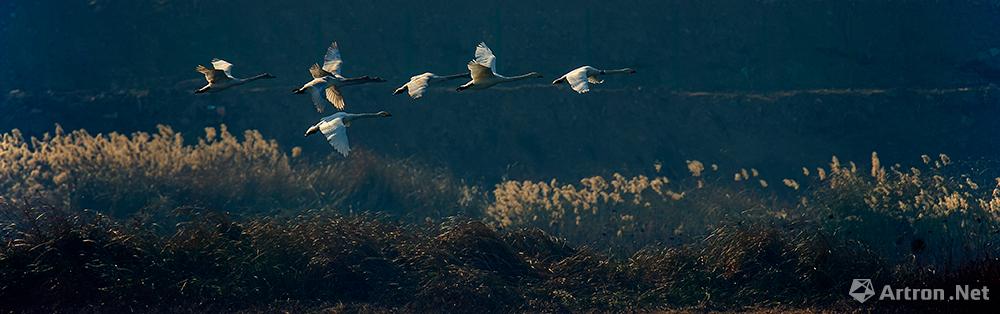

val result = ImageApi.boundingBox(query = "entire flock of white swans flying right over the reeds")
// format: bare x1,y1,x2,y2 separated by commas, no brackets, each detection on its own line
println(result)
195,42,635,157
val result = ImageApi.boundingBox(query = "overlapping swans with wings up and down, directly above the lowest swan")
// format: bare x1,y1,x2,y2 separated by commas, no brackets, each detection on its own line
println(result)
292,42,385,112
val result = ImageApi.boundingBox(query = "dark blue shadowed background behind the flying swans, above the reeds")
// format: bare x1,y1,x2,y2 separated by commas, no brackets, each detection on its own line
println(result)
0,0,1000,182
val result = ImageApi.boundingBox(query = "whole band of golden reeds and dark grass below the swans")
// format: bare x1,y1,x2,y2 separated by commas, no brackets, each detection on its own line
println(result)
0,128,1000,313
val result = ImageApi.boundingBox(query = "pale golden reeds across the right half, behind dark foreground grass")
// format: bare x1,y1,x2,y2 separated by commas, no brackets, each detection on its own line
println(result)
486,153,1000,265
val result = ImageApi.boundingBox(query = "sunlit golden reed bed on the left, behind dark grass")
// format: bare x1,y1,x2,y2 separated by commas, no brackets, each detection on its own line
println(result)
0,125,478,219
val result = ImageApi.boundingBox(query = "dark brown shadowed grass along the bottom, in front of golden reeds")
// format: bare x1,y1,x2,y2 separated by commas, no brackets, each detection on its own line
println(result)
0,203,1000,313
